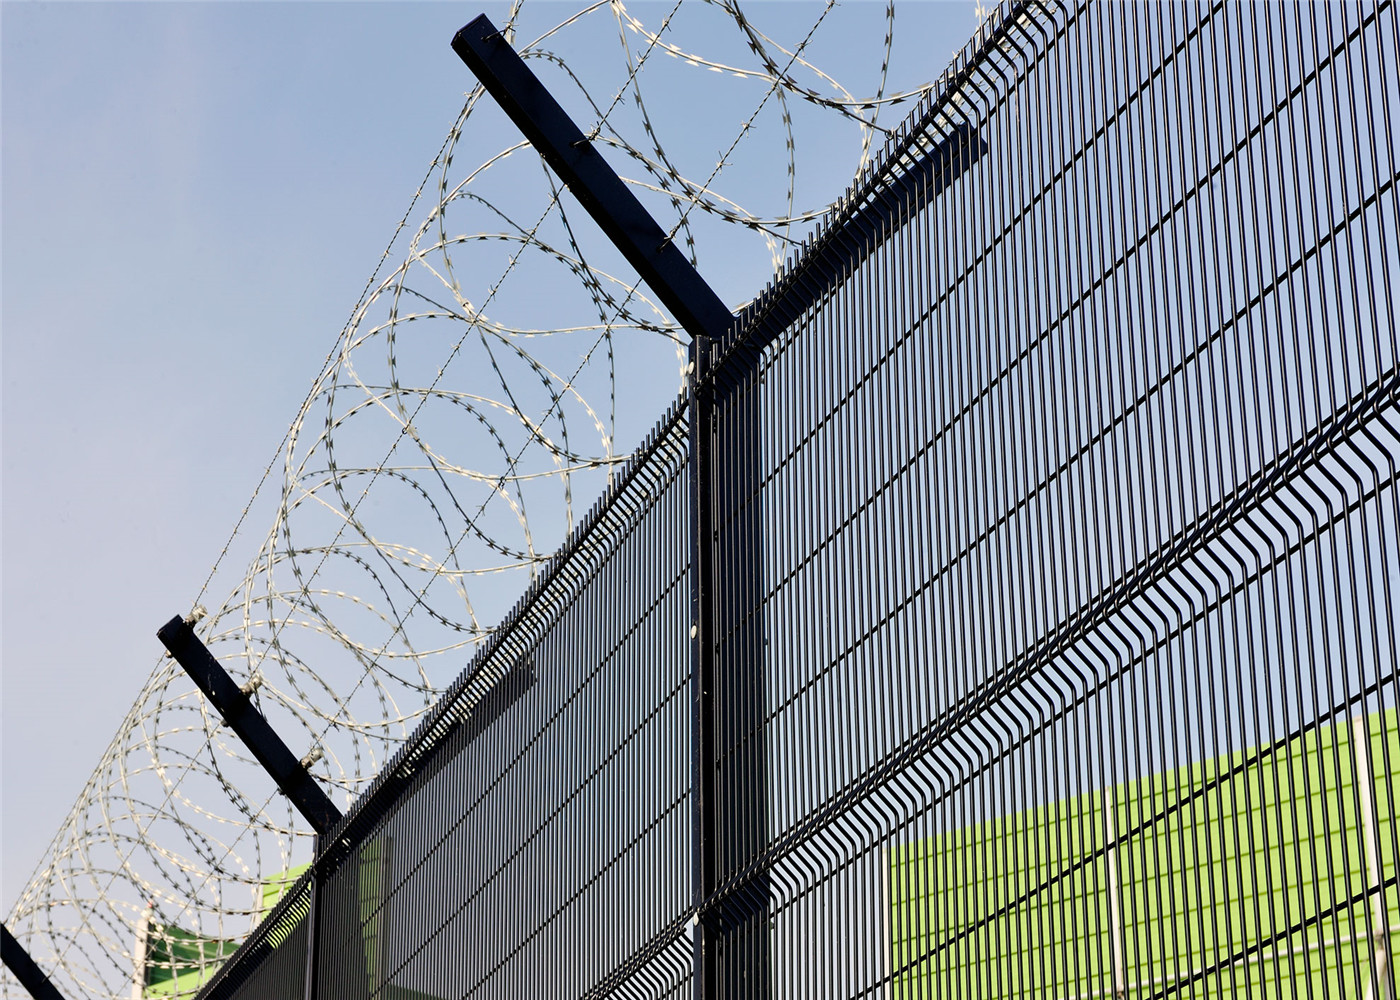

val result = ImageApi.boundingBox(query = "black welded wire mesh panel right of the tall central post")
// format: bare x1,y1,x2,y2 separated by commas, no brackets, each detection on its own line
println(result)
708,1,1400,999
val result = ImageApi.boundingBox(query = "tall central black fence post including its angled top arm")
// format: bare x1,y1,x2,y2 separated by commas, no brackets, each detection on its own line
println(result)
452,14,769,997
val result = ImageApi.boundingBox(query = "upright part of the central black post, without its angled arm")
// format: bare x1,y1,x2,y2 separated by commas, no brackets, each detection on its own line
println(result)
689,330,770,1000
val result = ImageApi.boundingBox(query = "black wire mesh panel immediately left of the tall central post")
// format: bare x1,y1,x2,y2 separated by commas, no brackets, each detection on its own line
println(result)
298,412,690,1000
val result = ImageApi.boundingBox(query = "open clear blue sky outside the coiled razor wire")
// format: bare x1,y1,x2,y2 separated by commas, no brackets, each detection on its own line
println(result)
0,0,974,910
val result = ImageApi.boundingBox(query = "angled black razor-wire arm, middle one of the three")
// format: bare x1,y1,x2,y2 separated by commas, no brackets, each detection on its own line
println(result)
155,615,340,836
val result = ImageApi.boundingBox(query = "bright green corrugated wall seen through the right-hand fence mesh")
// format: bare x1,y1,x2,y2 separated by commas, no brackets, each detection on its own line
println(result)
890,710,1400,1000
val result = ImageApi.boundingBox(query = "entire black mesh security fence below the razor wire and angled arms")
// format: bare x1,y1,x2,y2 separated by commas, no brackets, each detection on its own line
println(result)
172,0,1400,1000
